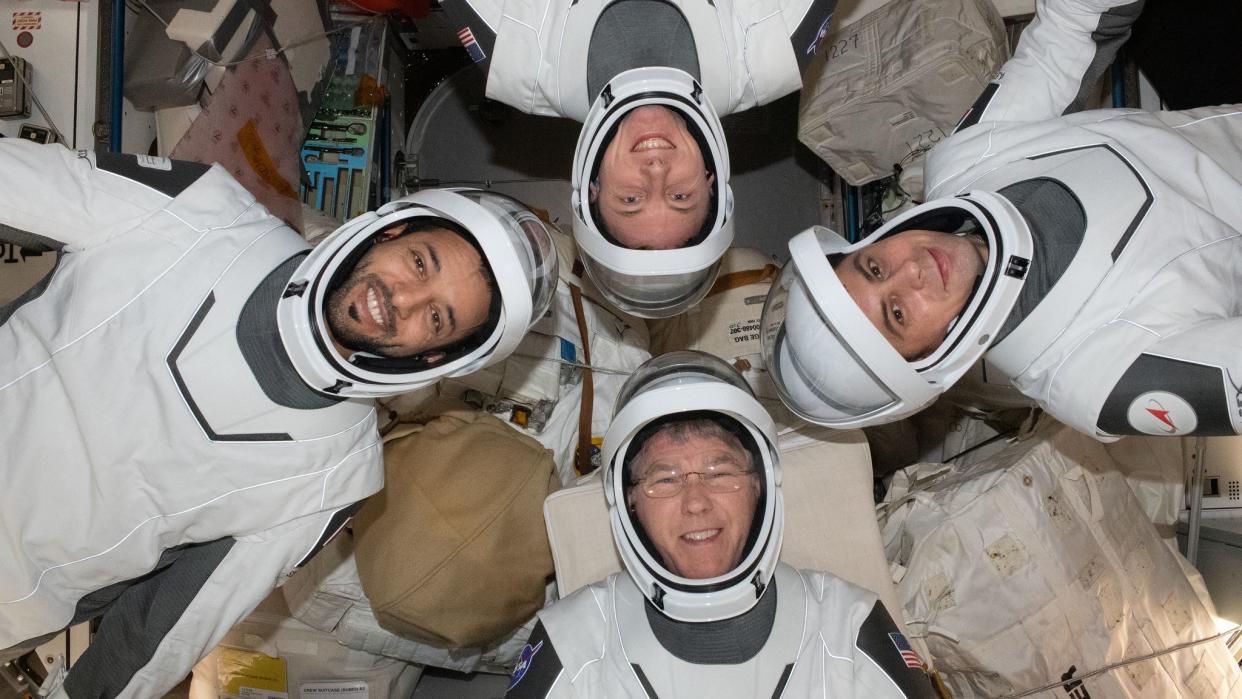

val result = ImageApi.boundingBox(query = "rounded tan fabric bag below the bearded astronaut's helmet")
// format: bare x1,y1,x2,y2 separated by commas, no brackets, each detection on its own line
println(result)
354,401,559,648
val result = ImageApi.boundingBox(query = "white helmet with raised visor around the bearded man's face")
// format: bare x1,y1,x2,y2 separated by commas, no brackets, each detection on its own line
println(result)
277,189,558,397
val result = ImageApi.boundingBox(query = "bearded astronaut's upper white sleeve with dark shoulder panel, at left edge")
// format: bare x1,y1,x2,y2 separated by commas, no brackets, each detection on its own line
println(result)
0,138,207,251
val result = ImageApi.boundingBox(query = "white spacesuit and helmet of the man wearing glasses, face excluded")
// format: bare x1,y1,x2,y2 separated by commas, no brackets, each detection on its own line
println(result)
507,351,935,699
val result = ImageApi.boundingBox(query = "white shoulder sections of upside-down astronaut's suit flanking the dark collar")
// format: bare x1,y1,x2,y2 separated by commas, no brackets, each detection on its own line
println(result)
468,0,811,122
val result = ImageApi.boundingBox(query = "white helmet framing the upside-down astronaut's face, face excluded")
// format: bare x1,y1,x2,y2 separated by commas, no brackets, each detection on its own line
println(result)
571,67,733,318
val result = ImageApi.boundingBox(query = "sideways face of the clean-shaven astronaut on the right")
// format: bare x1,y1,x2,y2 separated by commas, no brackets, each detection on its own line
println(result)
836,230,987,360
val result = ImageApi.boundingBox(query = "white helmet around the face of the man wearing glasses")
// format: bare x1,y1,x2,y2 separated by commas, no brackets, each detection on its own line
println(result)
604,351,785,622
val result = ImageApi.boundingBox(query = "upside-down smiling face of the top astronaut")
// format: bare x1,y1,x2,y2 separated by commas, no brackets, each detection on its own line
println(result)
590,104,715,250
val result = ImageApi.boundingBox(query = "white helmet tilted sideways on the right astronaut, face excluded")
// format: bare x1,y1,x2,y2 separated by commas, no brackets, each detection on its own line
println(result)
761,192,1032,428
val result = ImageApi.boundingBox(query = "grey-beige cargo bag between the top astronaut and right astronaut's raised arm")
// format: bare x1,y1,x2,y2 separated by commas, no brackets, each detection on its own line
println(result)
797,0,1009,186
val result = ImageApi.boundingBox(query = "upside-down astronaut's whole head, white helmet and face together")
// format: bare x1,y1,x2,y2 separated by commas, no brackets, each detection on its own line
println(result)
571,67,733,318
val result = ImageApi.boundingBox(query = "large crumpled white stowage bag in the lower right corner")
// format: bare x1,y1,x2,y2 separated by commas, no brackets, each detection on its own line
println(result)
879,420,1242,699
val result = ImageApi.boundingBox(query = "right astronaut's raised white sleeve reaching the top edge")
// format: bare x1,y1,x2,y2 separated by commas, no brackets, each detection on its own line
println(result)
958,0,1144,130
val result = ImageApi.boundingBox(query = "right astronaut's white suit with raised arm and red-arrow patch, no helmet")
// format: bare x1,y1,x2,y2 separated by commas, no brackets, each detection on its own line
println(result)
925,0,1242,440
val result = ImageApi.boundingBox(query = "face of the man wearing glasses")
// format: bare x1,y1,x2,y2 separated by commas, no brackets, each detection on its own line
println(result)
627,428,760,580
